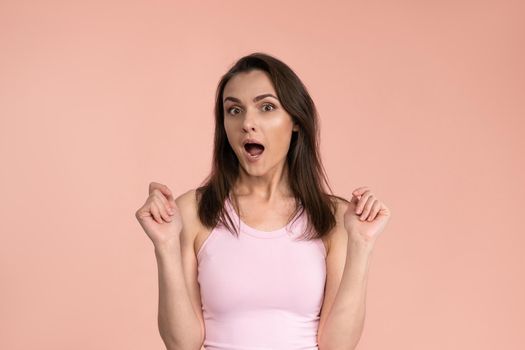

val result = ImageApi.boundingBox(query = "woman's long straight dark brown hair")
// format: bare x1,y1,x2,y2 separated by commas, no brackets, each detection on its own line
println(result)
196,52,348,239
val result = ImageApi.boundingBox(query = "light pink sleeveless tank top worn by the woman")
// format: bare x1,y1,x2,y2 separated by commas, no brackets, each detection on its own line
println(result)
197,199,326,350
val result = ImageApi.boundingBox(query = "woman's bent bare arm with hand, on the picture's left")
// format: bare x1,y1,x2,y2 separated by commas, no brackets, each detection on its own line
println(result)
135,182,205,350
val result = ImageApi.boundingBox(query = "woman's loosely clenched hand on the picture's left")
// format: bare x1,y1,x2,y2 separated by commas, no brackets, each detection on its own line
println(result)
135,182,182,247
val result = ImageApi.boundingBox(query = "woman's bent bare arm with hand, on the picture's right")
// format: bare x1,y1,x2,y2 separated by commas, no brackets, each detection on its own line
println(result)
318,186,391,350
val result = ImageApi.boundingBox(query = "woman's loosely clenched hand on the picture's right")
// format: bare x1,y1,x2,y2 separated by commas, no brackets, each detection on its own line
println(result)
344,186,391,246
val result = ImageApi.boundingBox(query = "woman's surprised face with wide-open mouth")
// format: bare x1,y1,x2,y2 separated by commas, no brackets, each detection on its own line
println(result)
223,70,298,176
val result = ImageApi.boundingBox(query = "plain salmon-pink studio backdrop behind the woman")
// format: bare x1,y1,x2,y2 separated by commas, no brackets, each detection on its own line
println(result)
0,0,525,350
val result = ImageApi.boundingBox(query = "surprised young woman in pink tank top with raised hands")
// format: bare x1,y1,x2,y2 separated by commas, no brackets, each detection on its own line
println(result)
135,53,391,350
